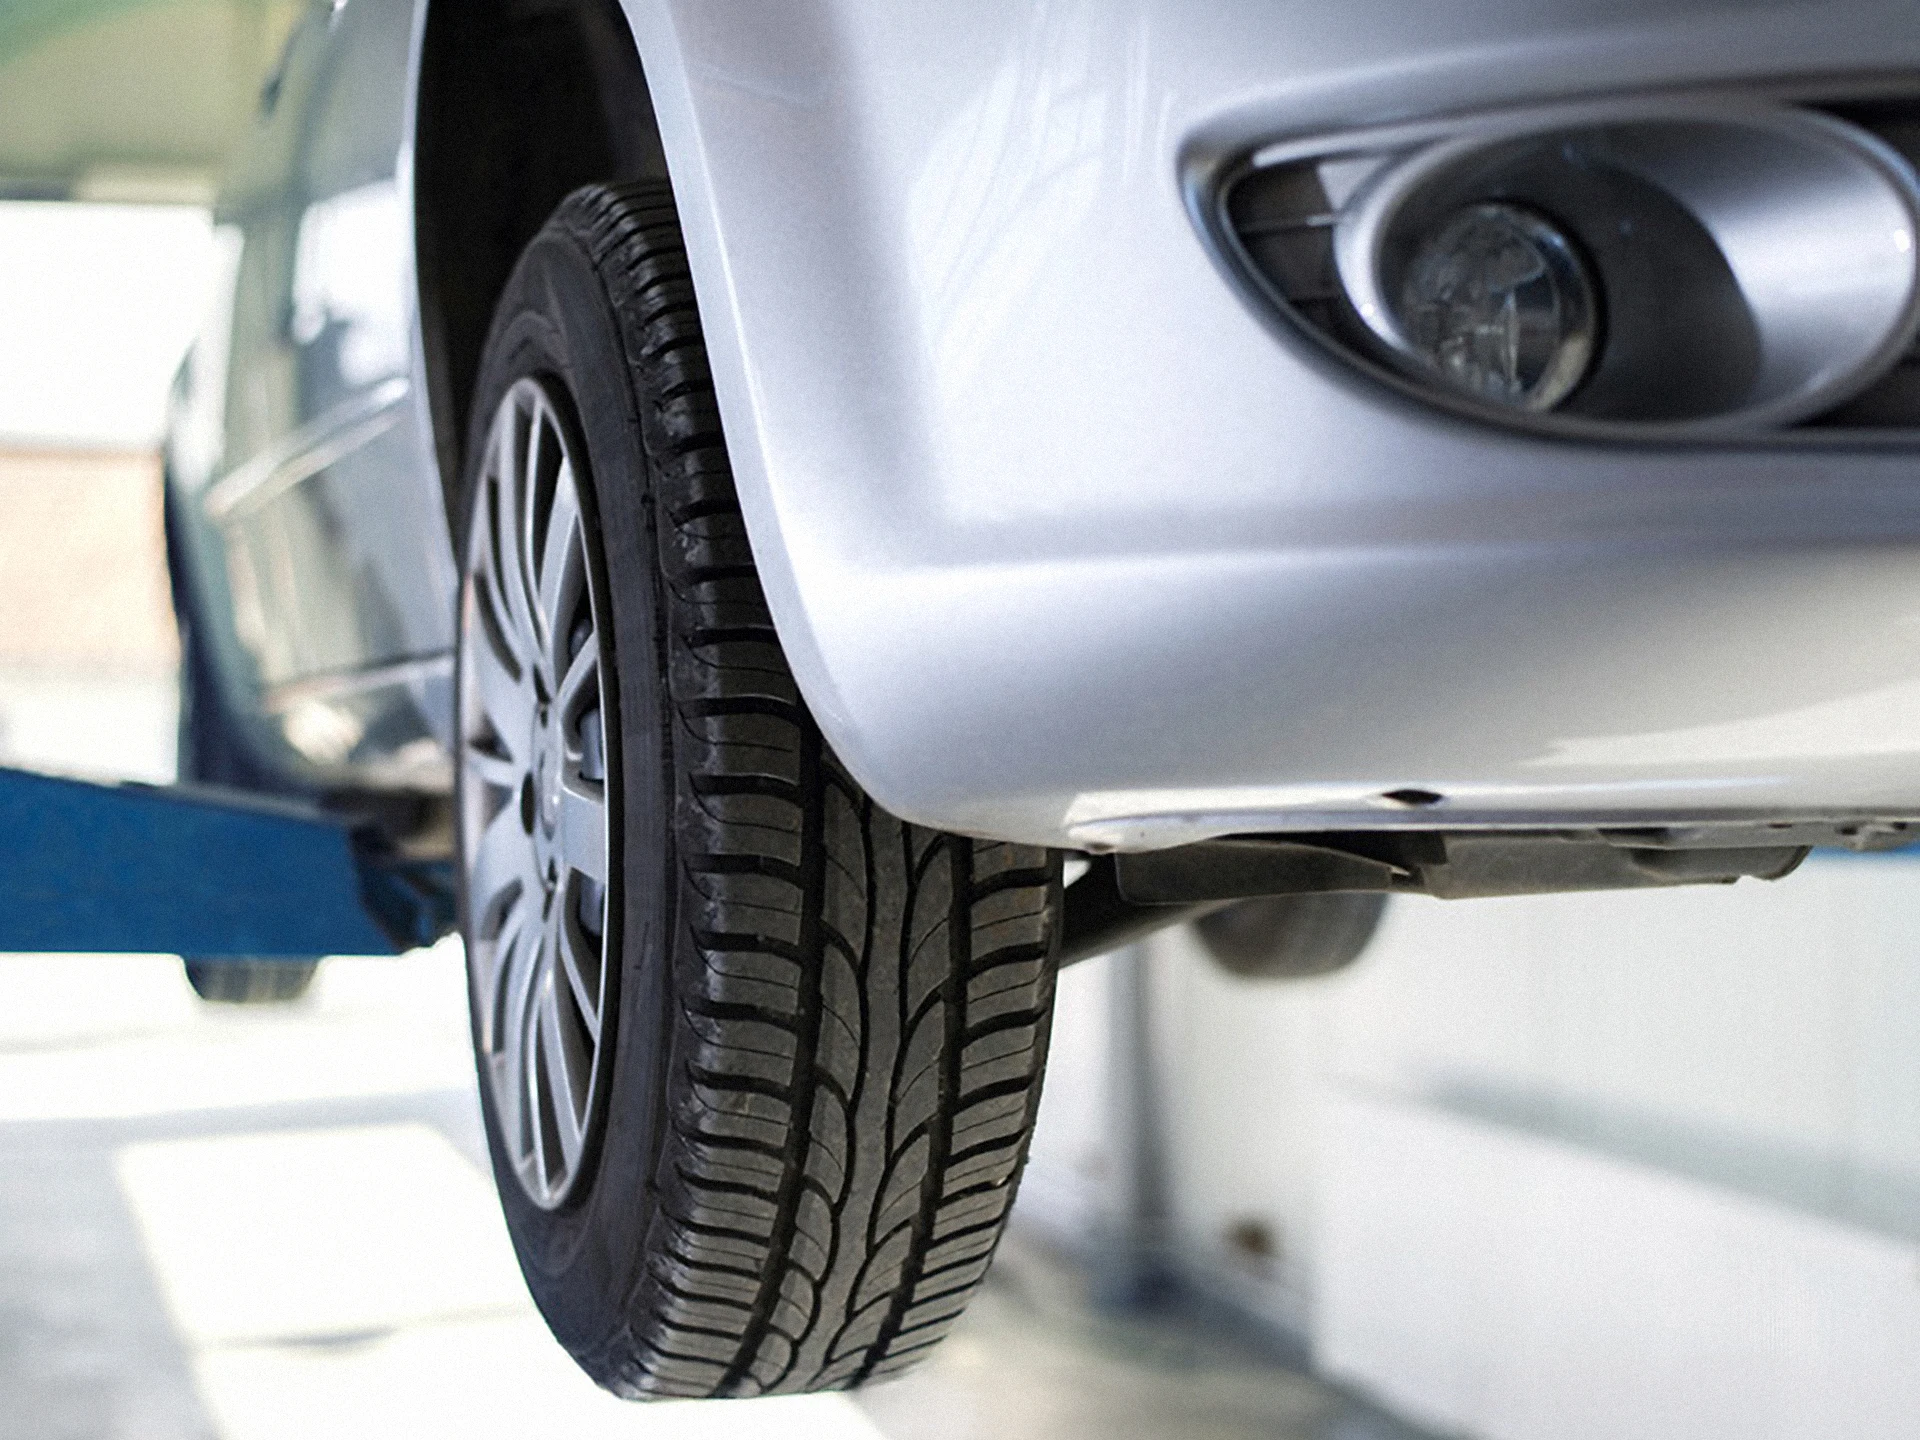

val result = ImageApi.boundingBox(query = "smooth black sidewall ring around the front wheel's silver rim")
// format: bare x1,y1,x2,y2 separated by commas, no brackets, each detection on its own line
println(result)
455,227,676,1361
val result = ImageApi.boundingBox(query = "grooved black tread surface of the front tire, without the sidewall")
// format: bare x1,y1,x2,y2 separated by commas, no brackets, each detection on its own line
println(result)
557,184,1060,1396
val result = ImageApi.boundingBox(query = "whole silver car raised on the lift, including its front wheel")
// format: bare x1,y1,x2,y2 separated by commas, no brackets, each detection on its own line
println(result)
167,0,1920,1396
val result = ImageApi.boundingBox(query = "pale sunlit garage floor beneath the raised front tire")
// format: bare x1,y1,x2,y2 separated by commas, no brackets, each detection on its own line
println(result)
0,947,1436,1440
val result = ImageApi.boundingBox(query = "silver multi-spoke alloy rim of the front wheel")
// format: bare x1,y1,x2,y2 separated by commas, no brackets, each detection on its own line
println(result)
459,380,611,1210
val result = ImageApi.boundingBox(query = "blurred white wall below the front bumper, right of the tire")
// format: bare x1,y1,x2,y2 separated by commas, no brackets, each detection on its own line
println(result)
1023,856,1920,1440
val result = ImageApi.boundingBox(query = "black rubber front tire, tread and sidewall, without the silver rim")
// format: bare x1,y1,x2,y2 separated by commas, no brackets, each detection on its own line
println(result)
455,182,1062,1398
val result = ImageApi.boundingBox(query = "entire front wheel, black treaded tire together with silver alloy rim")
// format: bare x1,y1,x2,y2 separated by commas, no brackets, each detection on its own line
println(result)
455,182,1062,1398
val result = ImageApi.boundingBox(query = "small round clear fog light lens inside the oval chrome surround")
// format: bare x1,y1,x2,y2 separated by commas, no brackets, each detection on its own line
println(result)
1400,204,1597,411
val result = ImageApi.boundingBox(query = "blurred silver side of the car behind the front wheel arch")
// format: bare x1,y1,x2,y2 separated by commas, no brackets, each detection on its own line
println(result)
167,0,455,791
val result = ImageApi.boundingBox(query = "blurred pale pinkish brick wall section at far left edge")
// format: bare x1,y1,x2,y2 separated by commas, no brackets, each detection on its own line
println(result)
0,449,179,678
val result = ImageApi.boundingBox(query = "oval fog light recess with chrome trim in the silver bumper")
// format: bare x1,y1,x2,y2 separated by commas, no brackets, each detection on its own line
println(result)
1219,94,1920,438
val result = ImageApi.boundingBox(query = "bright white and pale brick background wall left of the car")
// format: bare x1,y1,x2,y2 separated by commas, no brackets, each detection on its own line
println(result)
0,179,213,781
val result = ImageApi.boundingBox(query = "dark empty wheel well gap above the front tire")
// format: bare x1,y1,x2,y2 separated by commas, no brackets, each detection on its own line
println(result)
413,0,666,514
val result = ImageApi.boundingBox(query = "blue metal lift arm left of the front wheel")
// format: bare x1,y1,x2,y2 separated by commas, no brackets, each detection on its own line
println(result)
0,768,455,960
